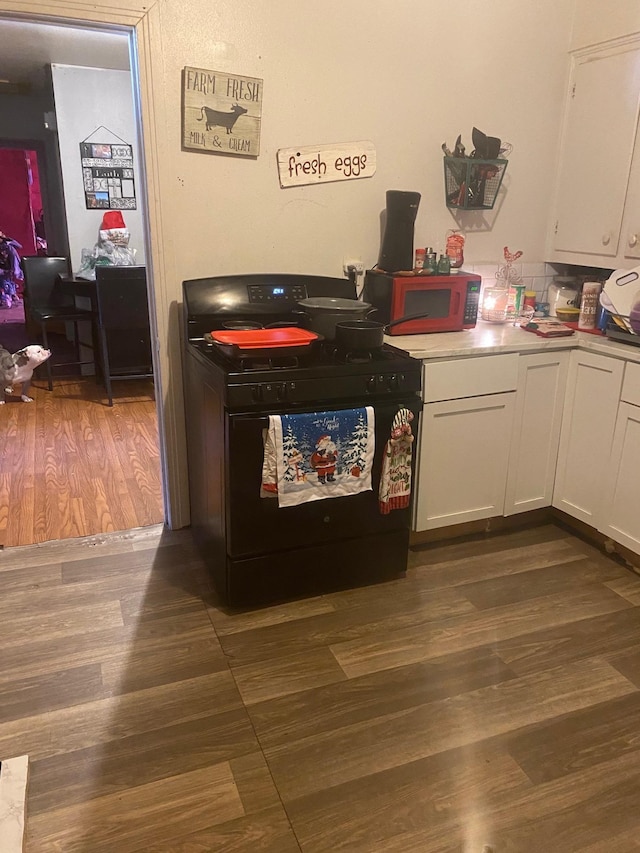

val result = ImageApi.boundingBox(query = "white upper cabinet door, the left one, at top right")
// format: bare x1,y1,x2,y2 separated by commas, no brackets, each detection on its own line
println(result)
550,41,640,266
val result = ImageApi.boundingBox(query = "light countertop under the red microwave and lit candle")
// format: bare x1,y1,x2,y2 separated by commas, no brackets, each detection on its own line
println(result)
385,320,640,362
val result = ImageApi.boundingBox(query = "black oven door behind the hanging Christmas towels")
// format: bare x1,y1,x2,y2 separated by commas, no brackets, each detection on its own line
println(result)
225,397,422,559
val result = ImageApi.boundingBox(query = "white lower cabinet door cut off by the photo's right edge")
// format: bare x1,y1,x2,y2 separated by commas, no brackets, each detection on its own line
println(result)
599,403,640,554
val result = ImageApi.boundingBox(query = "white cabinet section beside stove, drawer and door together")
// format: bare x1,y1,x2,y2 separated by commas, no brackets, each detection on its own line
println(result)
414,354,518,531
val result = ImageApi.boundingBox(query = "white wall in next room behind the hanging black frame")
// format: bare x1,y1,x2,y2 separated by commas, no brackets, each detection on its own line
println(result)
51,62,145,271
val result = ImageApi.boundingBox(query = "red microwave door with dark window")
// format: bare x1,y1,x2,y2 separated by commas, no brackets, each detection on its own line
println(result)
389,276,466,335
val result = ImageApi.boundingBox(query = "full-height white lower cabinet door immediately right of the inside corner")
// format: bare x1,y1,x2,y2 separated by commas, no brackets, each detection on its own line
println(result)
553,350,624,528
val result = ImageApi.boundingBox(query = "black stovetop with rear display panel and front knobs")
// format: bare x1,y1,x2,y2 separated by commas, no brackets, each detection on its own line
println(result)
183,274,421,408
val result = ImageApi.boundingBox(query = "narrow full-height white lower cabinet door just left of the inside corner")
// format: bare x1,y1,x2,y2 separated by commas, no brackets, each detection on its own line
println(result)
504,351,569,515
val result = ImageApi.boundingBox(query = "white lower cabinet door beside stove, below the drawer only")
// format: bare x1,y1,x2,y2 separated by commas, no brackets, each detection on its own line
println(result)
414,392,516,531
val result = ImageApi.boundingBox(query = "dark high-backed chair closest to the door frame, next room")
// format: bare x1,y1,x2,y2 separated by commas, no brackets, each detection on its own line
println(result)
95,266,153,406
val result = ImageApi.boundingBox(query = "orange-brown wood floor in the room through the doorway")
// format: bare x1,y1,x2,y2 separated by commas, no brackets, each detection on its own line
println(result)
0,377,164,547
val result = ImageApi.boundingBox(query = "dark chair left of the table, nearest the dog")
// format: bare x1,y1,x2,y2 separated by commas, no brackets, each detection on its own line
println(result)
22,255,93,391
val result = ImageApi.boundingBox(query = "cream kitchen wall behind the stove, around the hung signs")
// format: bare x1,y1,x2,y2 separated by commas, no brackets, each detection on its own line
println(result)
156,0,574,278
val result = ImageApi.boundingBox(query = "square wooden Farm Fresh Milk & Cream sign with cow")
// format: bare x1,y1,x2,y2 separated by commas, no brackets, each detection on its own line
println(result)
182,66,263,157
